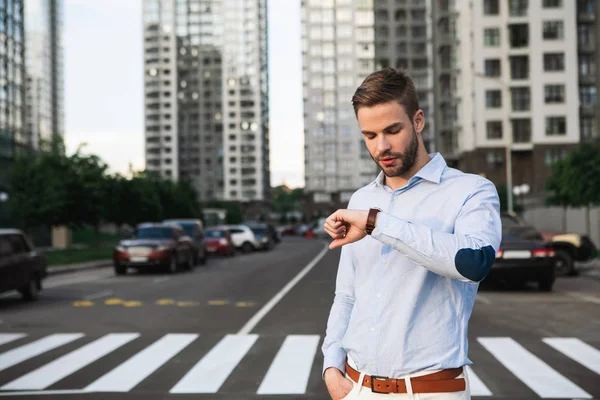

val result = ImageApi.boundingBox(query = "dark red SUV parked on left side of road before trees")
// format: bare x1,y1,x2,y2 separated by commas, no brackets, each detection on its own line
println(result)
113,223,194,275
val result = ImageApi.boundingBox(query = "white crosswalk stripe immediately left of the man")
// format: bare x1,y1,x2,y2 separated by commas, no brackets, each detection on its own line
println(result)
256,335,320,395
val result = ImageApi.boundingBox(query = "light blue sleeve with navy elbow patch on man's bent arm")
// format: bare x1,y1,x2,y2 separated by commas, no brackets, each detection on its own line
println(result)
372,178,502,282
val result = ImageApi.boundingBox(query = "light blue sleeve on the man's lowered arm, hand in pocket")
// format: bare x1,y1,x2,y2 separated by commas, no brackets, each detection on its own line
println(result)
322,246,355,374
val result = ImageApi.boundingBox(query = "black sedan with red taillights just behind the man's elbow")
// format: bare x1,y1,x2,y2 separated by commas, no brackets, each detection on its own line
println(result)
485,215,556,292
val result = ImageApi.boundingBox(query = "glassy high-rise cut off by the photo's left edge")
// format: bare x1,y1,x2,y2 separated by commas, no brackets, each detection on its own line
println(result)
0,0,29,191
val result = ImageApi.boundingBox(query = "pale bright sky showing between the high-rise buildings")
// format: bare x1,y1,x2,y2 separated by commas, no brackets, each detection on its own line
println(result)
64,0,304,187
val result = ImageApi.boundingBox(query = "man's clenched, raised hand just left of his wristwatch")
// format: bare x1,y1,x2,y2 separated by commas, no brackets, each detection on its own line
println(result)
324,210,369,249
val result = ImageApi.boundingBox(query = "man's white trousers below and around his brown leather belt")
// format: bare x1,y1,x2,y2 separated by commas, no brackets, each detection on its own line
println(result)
342,360,471,400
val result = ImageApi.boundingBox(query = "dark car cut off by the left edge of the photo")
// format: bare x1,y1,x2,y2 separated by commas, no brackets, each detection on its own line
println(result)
0,229,48,300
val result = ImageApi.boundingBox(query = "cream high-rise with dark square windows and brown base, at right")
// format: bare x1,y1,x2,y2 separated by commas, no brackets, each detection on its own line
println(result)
433,0,580,199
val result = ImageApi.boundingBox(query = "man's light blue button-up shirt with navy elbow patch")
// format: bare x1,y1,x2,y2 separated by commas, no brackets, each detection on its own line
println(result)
322,153,502,378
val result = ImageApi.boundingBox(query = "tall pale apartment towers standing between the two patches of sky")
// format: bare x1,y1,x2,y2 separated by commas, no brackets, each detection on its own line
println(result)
143,0,270,214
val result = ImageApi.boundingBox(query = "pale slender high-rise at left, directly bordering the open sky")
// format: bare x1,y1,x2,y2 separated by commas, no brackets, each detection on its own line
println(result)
25,0,64,149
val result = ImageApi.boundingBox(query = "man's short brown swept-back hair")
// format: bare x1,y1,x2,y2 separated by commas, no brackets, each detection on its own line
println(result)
352,68,419,121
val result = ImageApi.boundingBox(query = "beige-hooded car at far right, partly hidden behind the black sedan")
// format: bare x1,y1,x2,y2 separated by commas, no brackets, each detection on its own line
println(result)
503,213,597,276
